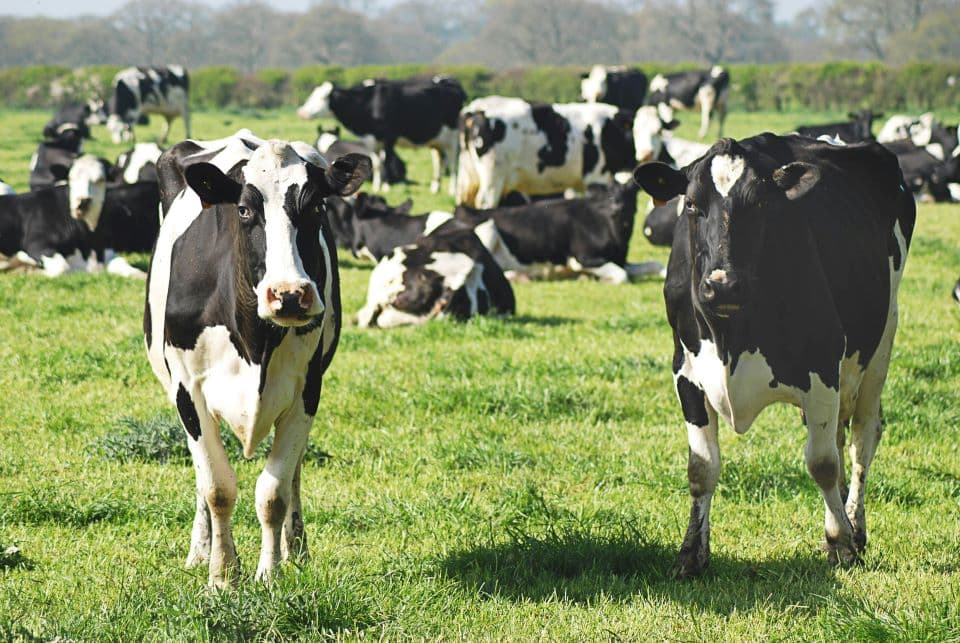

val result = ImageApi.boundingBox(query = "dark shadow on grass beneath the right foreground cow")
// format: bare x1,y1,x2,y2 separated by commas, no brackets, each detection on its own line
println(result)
441,535,840,615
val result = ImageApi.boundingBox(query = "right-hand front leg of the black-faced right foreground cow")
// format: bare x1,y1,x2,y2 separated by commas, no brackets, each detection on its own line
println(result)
803,380,858,566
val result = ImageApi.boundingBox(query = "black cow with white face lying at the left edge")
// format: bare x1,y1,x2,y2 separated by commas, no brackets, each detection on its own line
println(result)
0,155,145,277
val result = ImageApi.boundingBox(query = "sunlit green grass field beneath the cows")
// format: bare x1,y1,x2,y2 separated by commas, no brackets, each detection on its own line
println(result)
0,107,960,641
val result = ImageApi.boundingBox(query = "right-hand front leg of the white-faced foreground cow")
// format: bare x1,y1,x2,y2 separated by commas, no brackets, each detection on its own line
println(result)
256,409,313,580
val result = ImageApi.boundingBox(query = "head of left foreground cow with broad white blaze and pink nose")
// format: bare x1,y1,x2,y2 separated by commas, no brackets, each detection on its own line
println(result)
184,141,370,326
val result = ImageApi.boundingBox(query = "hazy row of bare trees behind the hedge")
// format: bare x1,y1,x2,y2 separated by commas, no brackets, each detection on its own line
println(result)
0,0,960,72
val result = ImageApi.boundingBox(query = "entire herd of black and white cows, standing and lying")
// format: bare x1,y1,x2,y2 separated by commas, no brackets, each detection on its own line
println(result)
0,61,960,586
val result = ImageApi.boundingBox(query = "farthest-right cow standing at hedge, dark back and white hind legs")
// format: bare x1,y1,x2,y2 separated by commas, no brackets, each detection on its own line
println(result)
645,65,730,138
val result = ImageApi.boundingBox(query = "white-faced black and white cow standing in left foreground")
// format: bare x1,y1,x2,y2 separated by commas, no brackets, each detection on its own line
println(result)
143,132,370,587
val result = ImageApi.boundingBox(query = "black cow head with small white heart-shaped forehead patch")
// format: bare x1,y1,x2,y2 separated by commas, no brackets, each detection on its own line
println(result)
634,139,820,318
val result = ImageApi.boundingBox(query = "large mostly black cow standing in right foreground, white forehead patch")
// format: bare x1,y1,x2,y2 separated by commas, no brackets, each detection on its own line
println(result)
635,134,916,576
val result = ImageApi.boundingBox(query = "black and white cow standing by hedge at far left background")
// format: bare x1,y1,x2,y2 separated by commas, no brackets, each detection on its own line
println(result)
107,65,190,143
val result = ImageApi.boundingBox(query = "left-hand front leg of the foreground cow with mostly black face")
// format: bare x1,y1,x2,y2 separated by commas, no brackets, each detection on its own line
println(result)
675,375,720,578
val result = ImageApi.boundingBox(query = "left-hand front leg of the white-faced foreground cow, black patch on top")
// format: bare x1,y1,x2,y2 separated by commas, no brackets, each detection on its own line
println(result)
177,388,240,587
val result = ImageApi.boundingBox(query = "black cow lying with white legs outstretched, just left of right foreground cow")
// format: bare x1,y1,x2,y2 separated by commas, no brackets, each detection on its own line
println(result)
454,181,663,284
